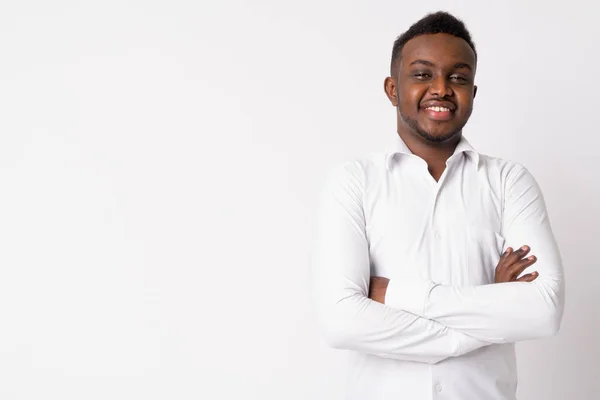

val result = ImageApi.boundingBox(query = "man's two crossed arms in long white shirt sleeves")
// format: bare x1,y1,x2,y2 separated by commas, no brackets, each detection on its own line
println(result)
313,164,564,363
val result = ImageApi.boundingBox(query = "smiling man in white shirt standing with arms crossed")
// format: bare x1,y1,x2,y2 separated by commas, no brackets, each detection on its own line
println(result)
314,12,564,400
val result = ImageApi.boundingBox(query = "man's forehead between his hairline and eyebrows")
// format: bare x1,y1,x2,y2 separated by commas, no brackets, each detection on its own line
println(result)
400,33,475,68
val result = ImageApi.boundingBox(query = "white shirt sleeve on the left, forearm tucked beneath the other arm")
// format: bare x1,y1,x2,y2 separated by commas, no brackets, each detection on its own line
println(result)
313,162,489,364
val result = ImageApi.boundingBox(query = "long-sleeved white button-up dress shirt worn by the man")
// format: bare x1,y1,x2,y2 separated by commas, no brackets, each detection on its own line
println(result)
313,137,564,400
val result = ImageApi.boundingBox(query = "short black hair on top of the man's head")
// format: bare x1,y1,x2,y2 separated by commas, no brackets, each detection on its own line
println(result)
390,11,477,76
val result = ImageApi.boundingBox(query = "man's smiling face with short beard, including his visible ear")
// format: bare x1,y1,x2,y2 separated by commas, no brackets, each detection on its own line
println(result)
385,33,477,143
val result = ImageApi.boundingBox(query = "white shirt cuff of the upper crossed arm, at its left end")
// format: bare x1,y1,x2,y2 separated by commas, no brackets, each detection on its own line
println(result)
384,277,435,317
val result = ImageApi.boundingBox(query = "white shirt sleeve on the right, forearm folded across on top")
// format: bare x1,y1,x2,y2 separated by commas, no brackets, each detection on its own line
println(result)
386,166,565,343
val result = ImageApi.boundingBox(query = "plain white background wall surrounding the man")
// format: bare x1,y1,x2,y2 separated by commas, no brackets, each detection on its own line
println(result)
0,0,600,400
